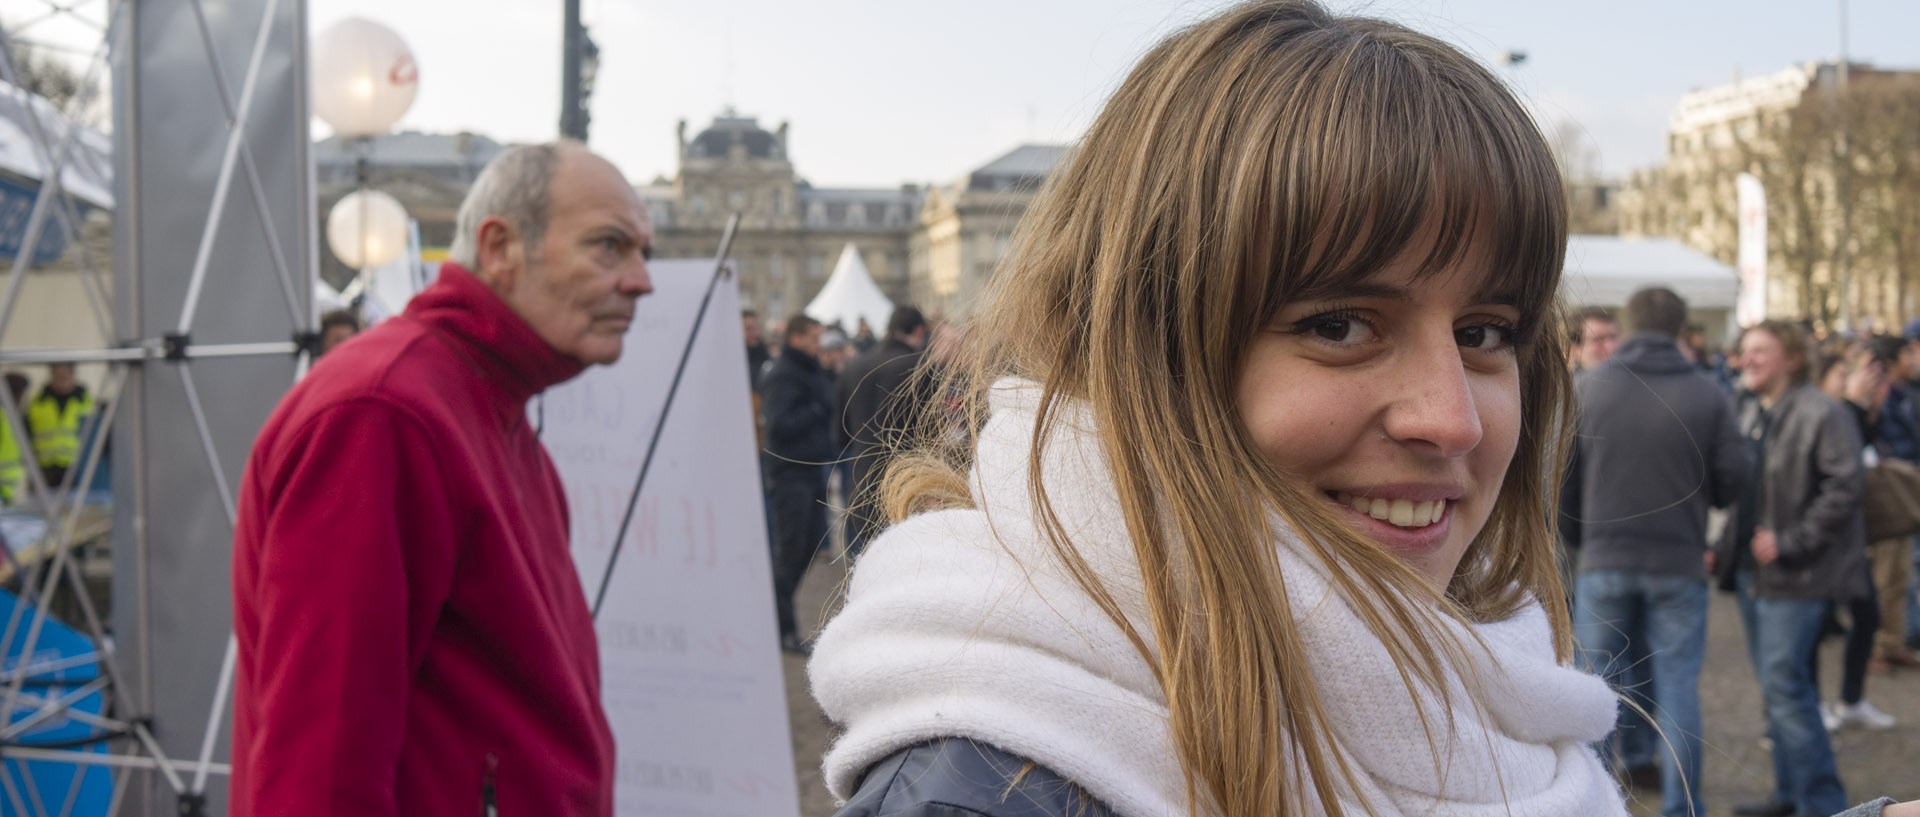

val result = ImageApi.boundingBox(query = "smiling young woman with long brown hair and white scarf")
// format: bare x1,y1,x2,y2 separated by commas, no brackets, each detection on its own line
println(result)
810,0,1912,817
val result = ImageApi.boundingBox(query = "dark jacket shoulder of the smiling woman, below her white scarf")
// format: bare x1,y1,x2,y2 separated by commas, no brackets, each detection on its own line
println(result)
837,738,1114,817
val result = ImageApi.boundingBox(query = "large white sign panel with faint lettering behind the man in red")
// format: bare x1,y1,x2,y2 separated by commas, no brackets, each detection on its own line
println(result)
534,261,799,817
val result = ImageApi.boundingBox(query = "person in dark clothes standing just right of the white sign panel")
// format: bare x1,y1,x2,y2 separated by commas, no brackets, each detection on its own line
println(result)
760,315,833,652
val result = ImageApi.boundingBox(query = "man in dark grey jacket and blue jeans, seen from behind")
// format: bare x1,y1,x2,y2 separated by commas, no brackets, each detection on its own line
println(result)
1559,288,1753,817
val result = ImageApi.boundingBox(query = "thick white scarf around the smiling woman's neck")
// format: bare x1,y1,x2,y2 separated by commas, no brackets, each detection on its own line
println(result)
808,382,1626,817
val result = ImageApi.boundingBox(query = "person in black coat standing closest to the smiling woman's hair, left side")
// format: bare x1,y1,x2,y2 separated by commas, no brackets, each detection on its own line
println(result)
833,307,931,556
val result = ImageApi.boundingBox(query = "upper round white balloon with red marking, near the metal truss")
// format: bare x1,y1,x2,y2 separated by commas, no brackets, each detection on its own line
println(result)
313,17,420,138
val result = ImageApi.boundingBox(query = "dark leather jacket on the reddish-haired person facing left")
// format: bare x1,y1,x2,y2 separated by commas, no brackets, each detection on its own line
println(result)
1715,384,1866,600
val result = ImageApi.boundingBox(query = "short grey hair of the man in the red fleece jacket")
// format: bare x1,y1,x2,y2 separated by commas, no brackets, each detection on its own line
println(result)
447,142,574,272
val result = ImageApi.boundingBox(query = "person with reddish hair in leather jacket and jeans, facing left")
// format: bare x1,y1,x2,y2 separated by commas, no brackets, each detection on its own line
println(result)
1713,320,1868,817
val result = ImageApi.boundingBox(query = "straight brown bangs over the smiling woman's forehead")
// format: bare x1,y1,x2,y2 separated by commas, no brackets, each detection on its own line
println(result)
1265,38,1565,327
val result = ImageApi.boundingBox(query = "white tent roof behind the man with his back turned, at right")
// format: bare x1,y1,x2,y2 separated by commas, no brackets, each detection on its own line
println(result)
1561,236,1740,309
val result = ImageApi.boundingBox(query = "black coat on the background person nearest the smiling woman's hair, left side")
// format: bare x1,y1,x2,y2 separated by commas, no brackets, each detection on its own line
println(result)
833,338,933,541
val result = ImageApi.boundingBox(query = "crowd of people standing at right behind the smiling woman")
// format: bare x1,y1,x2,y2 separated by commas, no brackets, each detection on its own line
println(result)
1559,288,1920,817
